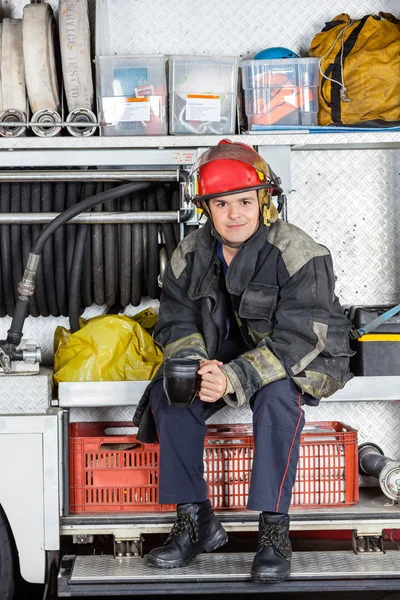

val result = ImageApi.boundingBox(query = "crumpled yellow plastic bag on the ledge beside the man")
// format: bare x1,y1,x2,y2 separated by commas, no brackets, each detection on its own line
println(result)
54,309,163,383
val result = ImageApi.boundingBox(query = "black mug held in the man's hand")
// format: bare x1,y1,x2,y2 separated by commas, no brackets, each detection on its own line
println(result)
164,358,200,408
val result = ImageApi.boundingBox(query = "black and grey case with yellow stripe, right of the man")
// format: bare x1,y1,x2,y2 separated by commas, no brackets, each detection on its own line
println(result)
349,306,400,376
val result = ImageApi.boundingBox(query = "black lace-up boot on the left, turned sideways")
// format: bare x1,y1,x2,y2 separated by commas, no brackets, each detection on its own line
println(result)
147,500,228,569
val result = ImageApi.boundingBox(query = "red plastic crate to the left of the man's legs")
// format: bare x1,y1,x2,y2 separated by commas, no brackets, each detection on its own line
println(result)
70,423,173,513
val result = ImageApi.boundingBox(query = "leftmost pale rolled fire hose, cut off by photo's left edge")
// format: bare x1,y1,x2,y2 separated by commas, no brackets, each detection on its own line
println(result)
0,19,27,137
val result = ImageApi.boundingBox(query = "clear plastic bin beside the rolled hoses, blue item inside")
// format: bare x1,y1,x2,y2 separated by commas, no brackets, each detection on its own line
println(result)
96,56,168,136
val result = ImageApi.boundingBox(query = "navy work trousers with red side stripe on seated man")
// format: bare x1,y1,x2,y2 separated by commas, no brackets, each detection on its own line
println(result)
150,379,304,513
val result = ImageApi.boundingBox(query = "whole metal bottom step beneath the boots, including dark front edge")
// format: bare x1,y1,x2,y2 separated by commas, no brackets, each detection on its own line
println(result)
58,550,400,597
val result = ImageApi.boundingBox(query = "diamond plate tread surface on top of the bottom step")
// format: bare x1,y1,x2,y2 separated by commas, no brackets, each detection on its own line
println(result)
70,551,400,586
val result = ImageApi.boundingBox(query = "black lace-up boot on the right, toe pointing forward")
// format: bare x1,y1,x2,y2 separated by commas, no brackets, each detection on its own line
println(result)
251,513,292,583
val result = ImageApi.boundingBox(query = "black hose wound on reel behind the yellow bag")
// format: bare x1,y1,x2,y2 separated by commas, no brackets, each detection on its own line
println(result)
0,175,193,373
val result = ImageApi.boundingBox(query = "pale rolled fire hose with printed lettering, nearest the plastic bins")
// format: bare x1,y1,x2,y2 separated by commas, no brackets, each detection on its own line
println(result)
59,0,97,137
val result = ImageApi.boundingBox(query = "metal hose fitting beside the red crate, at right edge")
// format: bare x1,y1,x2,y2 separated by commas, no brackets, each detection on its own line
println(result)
358,442,400,502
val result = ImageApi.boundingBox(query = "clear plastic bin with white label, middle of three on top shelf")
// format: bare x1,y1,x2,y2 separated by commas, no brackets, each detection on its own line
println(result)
169,56,238,135
